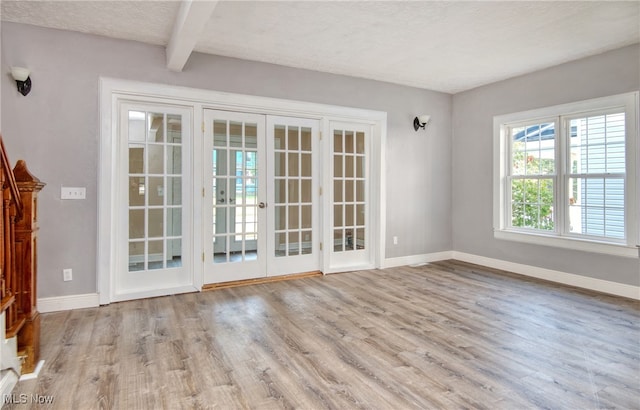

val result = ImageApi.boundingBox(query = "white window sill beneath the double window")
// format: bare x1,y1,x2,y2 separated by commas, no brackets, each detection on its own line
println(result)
493,229,640,258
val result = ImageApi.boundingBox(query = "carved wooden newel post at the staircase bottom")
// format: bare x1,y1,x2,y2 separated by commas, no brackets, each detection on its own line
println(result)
13,160,46,373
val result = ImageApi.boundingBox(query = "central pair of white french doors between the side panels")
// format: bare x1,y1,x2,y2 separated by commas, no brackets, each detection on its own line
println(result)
203,110,320,283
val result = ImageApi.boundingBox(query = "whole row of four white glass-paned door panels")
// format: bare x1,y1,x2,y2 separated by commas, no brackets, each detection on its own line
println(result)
109,102,373,301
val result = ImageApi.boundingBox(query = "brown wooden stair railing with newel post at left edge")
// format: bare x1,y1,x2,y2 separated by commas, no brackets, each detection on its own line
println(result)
0,136,45,373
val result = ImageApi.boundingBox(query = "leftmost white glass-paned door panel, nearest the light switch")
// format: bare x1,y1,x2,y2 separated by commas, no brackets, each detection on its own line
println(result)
112,103,194,300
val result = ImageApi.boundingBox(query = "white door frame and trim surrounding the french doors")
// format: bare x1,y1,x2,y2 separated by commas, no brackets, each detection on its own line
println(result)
96,77,387,304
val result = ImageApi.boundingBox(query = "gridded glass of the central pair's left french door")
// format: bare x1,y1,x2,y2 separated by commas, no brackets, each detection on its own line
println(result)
211,120,258,264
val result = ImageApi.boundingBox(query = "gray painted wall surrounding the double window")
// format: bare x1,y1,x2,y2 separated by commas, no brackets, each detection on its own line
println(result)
452,45,640,286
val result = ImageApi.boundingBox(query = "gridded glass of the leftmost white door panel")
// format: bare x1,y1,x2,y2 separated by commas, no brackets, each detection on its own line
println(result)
128,110,183,272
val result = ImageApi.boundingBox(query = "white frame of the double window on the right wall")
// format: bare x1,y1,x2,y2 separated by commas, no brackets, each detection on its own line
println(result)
493,91,640,258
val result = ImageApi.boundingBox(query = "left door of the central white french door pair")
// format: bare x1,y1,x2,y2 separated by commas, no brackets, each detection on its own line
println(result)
203,110,267,283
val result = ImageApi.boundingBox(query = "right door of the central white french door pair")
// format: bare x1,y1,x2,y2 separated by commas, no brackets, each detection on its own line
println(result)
267,116,322,276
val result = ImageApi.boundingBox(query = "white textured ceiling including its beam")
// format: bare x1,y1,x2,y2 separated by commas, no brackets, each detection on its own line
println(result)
2,0,640,93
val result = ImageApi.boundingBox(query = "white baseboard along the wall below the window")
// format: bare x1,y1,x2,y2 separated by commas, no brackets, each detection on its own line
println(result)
452,251,640,300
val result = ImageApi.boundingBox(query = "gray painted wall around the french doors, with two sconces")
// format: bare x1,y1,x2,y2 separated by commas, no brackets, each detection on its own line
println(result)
1,22,452,297
